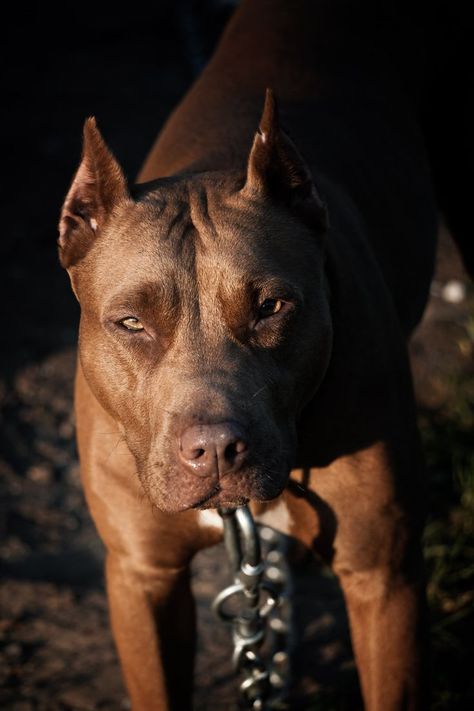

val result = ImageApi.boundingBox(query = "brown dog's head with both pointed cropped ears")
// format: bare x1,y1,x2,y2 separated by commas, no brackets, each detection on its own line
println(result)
59,92,331,512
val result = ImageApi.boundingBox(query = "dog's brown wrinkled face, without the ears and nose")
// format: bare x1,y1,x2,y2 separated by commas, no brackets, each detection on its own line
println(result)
73,176,331,511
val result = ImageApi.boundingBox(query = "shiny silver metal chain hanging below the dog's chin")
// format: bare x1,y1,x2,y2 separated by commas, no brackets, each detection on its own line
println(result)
212,506,289,711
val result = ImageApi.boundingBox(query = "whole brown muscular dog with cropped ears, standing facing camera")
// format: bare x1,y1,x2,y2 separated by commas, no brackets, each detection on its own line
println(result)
60,0,436,711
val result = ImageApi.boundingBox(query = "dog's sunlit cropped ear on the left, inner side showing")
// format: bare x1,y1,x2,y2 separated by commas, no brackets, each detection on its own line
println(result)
58,118,129,269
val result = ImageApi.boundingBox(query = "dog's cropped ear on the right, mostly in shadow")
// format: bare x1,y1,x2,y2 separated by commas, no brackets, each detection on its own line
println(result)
243,89,327,230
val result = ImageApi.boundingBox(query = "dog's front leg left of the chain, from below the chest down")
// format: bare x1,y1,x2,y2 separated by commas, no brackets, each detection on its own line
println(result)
106,553,195,711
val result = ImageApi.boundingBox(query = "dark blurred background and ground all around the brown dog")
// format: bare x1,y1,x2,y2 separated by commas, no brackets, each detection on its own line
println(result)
0,0,474,711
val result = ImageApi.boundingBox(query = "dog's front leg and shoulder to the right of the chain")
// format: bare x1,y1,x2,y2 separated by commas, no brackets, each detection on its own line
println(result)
304,444,427,711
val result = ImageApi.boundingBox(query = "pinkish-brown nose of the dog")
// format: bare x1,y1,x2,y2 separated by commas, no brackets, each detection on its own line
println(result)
179,422,248,477
